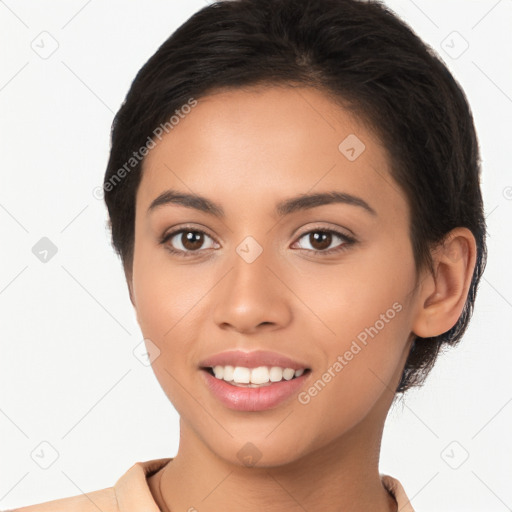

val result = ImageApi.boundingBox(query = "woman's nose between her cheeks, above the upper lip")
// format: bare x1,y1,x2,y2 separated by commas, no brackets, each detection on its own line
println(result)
214,245,293,334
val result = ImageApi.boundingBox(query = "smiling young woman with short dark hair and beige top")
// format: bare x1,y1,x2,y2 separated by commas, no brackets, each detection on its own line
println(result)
11,0,486,512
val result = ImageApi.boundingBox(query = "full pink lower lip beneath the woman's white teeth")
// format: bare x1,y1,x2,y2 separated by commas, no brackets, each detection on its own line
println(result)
201,370,311,411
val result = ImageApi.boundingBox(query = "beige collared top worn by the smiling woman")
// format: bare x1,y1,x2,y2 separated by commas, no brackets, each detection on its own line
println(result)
9,458,414,512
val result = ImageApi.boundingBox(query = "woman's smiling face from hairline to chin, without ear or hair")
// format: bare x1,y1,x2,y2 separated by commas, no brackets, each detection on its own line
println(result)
129,87,419,465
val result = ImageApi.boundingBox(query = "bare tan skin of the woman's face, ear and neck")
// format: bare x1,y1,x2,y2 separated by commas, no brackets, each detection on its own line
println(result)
127,86,476,512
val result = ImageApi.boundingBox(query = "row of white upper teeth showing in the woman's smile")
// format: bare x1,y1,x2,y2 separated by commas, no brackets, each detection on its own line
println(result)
212,365,304,387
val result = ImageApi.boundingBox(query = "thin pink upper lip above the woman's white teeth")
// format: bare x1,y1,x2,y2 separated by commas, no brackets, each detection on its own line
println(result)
199,350,308,370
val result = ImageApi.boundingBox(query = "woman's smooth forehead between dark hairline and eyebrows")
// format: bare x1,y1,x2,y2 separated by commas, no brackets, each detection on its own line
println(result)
137,87,405,222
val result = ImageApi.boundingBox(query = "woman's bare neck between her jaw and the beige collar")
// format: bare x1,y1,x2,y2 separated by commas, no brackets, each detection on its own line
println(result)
153,404,397,512
